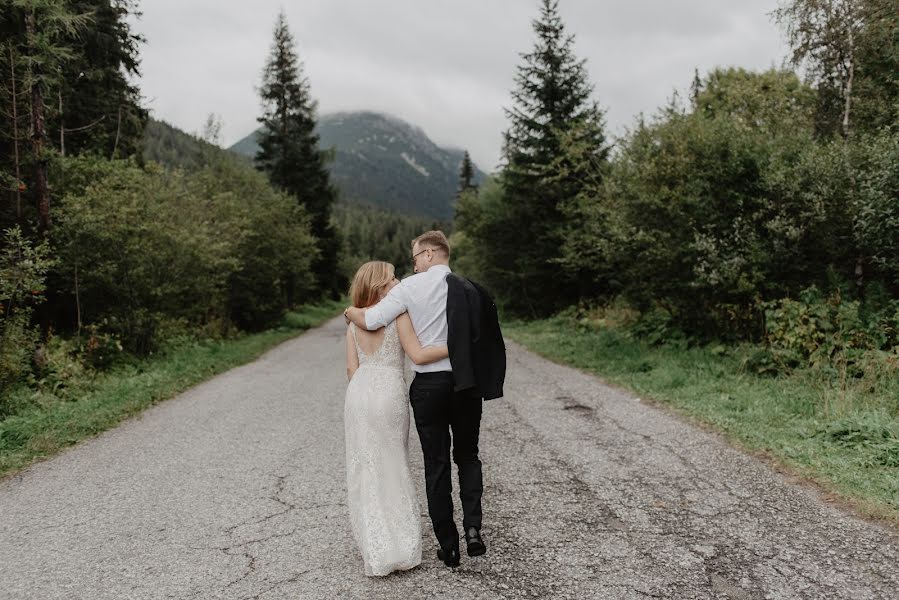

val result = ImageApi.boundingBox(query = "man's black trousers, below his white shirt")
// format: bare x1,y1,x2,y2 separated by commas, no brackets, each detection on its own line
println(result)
409,371,484,548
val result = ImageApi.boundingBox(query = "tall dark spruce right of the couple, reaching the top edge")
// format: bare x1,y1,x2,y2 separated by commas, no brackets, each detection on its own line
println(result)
491,0,609,315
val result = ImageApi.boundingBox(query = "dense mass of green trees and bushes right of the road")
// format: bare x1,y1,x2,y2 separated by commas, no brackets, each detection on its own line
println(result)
454,0,899,360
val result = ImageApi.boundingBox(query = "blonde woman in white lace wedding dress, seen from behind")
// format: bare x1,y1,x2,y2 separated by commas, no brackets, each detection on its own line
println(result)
344,262,447,576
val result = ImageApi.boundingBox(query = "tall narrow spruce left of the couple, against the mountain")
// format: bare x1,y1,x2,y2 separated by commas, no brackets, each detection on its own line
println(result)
256,11,344,296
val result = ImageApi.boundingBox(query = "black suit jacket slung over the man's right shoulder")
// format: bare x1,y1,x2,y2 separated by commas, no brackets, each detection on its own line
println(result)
446,273,506,400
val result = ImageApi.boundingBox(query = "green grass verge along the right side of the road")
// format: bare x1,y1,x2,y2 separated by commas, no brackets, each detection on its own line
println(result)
503,317,899,524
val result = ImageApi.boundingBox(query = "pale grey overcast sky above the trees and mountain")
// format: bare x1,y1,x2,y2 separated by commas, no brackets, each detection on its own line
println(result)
134,0,786,171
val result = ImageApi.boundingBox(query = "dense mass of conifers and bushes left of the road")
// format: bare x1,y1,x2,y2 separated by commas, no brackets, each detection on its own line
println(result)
0,0,336,414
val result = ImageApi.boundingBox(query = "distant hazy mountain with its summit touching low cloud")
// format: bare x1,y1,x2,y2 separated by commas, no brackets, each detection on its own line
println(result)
229,112,484,219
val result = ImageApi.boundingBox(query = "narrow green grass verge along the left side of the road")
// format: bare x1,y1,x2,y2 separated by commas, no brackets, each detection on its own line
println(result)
0,300,346,477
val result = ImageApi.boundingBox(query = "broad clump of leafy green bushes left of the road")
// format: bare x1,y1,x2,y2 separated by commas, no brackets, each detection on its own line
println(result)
53,157,316,352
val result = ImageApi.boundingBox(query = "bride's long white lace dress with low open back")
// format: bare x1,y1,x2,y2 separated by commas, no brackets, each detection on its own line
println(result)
344,321,421,576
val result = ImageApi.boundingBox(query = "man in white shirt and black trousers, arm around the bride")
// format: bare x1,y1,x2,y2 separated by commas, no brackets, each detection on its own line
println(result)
344,231,500,567
